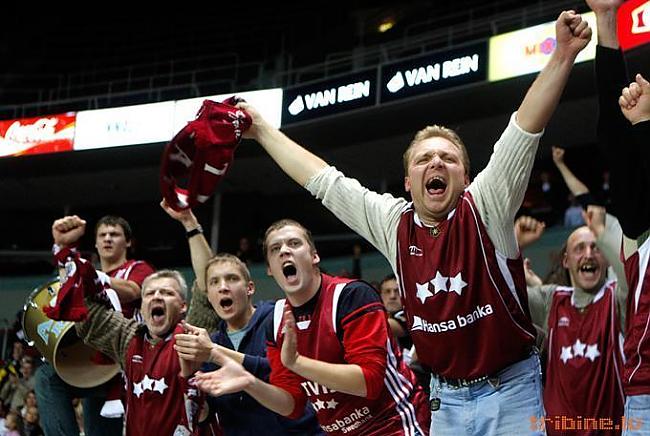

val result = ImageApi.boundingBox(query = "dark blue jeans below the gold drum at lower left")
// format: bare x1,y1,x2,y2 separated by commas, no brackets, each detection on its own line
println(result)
34,362,122,436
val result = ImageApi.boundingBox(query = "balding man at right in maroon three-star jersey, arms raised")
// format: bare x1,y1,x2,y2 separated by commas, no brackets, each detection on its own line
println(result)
515,206,628,435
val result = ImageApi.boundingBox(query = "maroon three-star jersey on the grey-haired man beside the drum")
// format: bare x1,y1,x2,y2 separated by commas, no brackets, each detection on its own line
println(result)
124,325,202,436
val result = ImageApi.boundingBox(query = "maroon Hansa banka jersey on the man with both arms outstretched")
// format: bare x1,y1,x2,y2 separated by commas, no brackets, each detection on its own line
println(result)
397,191,535,379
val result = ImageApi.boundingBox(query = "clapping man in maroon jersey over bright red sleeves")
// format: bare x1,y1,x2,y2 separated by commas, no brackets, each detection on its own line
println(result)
189,220,429,436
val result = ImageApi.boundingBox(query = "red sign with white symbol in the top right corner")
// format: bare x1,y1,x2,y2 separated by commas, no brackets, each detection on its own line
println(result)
618,0,650,51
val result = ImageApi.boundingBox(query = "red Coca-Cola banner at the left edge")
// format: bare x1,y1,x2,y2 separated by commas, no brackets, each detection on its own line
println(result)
0,112,76,157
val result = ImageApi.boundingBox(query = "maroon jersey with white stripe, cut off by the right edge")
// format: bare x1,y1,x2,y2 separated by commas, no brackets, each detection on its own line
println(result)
623,238,650,395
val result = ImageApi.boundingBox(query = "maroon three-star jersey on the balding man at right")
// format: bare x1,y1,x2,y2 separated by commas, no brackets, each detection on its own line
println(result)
544,282,625,435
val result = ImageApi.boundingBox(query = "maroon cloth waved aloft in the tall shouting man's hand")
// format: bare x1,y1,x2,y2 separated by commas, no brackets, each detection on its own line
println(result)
160,97,252,211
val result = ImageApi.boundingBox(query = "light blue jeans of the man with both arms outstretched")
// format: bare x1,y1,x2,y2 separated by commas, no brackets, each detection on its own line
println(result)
430,354,545,436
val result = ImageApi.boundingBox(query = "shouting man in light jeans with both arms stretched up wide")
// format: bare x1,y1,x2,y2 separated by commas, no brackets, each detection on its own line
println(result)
238,11,591,436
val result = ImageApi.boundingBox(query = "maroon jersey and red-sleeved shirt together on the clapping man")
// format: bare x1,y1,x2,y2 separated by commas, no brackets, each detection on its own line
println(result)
267,274,430,436
